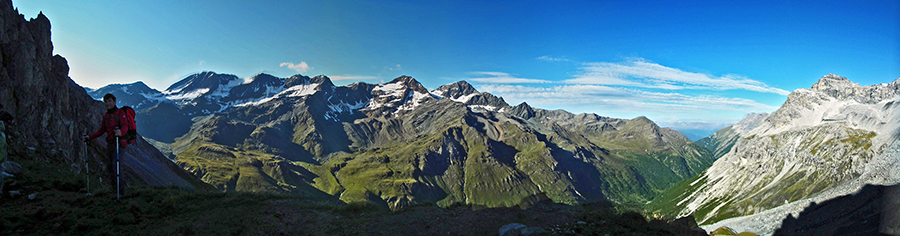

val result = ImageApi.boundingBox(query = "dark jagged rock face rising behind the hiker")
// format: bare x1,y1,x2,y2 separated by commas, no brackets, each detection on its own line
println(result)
0,1,85,162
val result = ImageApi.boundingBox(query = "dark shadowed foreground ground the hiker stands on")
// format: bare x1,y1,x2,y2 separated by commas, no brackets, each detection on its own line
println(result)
0,154,704,235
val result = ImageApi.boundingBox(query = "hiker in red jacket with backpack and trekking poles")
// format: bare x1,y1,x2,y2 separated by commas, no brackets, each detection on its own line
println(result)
84,93,130,200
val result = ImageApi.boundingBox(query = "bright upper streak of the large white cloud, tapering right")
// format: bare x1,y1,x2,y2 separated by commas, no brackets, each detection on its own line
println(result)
563,59,790,95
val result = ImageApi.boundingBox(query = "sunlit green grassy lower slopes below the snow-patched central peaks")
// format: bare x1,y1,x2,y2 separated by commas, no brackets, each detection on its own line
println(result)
176,114,710,210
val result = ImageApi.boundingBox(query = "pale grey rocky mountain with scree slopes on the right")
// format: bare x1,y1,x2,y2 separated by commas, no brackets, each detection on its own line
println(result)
654,74,900,234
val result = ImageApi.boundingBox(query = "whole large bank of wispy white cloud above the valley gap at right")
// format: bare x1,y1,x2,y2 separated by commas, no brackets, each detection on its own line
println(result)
468,56,789,121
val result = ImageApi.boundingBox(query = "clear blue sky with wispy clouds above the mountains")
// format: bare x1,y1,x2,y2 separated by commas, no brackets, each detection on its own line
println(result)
13,0,900,129
